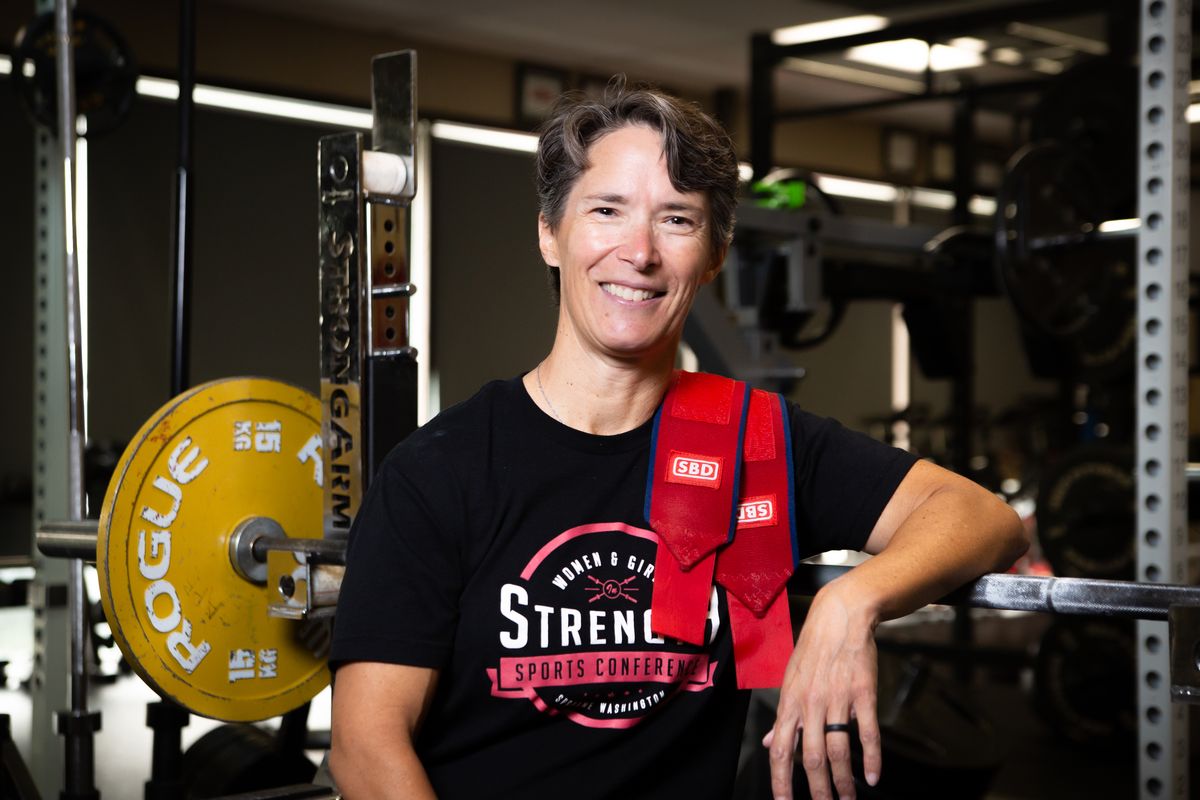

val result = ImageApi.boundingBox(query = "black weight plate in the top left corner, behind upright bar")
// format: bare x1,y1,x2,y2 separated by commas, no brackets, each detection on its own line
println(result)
12,10,138,137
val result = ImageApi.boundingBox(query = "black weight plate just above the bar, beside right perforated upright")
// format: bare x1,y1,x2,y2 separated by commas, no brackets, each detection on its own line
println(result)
1037,445,1136,581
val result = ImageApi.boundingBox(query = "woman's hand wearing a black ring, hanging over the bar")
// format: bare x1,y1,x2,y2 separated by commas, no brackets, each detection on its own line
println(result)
763,582,882,800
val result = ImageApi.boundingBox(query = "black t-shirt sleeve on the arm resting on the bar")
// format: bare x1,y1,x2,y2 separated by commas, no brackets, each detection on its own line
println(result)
790,407,917,558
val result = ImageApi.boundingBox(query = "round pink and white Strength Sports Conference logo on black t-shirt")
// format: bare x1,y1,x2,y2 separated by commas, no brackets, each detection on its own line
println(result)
487,523,720,728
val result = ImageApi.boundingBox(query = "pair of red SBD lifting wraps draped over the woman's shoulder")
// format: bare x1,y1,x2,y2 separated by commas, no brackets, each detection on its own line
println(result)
647,372,796,688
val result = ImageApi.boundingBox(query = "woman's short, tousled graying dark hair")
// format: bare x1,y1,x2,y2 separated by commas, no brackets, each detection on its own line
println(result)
535,76,738,301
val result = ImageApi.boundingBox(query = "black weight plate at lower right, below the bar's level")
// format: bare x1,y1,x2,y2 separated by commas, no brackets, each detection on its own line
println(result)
1034,620,1138,747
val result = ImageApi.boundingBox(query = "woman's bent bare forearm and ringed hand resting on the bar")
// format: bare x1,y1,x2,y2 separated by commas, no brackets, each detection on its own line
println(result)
763,462,1028,800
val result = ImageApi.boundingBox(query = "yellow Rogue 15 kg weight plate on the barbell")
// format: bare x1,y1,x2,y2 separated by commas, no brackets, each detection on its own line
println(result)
96,378,329,722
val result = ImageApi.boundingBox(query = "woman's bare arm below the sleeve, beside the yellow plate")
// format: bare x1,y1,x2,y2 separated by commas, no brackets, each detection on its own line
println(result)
329,661,438,800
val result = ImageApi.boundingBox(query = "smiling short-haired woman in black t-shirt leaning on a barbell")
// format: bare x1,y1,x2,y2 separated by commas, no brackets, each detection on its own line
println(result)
330,84,1026,798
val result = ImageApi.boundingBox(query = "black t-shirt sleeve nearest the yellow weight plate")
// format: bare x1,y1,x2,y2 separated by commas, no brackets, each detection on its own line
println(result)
330,443,462,669
